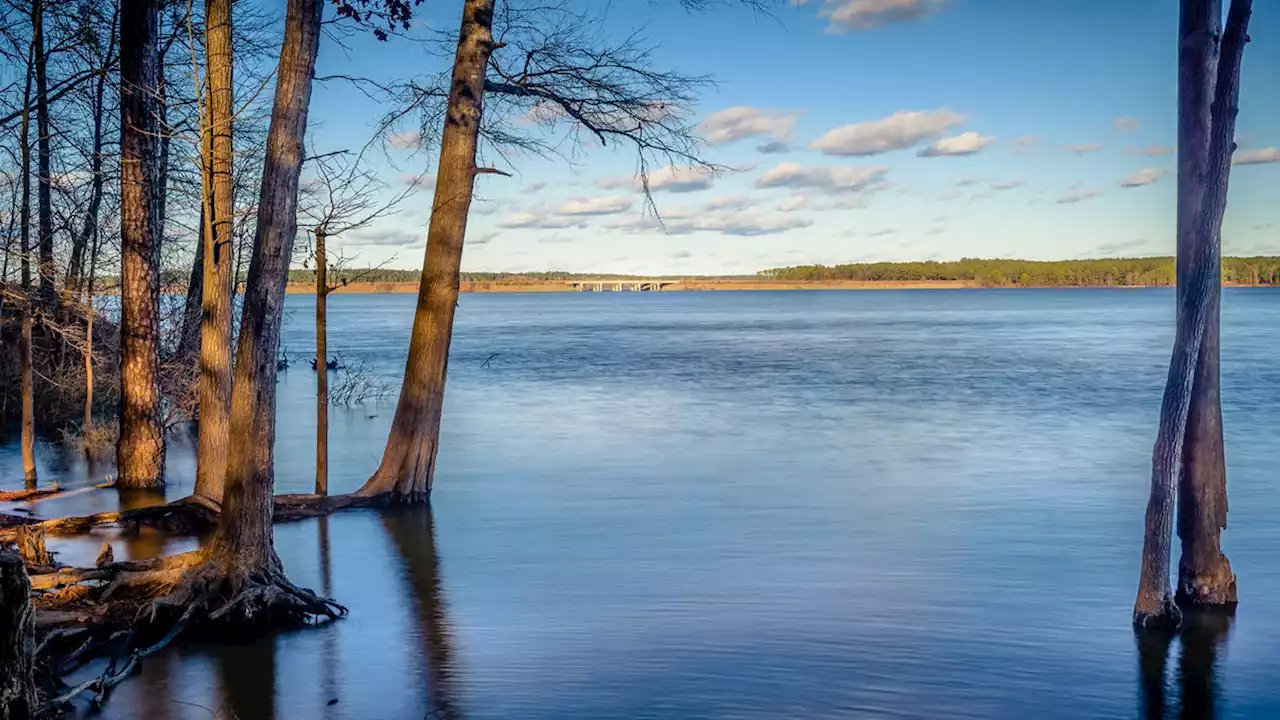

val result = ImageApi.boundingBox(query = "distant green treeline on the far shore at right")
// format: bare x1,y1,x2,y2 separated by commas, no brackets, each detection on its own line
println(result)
760,256,1280,287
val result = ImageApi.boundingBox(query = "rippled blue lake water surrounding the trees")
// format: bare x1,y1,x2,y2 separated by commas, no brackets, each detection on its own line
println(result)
0,290,1280,720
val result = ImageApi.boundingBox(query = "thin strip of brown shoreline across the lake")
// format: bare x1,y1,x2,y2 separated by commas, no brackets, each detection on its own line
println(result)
287,278,977,295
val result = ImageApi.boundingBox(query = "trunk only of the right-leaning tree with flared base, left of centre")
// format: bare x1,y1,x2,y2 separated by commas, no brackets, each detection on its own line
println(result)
357,0,494,502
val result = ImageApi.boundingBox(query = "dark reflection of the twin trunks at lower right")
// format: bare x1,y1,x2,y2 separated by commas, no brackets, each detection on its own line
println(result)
1135,611,1234,720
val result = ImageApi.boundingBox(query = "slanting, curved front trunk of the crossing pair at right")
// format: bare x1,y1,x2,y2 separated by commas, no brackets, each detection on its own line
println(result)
1133,0,1252,628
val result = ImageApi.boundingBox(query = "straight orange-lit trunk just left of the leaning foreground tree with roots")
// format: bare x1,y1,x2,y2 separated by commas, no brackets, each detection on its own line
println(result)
196,0,238,502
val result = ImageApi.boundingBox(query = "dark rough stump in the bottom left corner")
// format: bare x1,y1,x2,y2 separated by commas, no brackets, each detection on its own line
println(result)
0,552,37,720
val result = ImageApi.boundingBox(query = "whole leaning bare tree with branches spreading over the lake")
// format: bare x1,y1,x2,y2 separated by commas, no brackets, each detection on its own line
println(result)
356,0,717,502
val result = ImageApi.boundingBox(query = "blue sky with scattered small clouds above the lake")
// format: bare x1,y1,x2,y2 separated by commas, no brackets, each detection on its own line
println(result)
302,0,1280,274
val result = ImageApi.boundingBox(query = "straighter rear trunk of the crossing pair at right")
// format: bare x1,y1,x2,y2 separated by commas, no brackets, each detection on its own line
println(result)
1176,1,1248,605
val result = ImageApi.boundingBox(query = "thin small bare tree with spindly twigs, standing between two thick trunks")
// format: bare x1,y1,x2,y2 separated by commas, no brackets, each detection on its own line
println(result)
301,151,413,495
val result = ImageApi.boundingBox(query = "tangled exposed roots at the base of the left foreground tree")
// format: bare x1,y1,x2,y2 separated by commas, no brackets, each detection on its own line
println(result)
37,551,347,712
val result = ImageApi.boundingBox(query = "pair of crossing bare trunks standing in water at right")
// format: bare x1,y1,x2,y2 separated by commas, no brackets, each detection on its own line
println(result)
1133,0,1253,628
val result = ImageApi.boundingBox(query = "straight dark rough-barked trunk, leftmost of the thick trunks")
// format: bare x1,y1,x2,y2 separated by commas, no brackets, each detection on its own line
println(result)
116,0,165,488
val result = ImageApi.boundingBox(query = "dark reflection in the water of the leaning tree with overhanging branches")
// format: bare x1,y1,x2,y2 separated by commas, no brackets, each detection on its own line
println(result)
383,505,463,719
